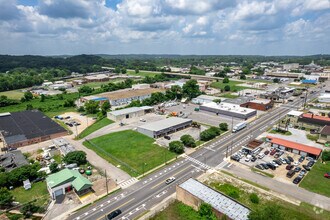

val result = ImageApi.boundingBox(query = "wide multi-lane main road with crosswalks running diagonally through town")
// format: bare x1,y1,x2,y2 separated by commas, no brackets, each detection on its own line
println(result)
68,87,324,220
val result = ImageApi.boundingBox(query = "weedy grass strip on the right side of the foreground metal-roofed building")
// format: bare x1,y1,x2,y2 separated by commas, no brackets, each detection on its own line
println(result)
210,180,330,220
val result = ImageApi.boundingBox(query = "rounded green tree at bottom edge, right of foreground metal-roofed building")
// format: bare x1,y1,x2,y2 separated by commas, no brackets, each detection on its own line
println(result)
248,203,284,220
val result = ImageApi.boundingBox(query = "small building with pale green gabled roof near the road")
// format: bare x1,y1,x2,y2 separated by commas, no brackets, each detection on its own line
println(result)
46,168,92,199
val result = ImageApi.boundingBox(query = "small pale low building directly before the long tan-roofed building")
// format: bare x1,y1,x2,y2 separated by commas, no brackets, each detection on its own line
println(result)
107,106,154,121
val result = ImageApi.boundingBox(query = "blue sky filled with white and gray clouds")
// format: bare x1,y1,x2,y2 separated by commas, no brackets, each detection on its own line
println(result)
0,0,330,55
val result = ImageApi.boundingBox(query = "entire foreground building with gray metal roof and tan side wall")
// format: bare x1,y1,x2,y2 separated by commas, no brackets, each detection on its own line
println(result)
176,178,250,220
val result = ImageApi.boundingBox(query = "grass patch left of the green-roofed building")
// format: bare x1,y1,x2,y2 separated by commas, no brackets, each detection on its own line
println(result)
12,181,49,206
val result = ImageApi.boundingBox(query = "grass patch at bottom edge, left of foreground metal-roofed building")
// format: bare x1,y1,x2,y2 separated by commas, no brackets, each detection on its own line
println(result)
150,201,201,220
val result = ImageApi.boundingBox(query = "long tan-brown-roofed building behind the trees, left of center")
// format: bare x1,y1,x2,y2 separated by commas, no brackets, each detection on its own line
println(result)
80,88,164,106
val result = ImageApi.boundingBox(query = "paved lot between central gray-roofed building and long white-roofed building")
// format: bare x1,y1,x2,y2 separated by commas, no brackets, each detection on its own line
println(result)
165,103,243,130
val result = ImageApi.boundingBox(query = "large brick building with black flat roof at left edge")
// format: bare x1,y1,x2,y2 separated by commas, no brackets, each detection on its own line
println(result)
0,110,68,148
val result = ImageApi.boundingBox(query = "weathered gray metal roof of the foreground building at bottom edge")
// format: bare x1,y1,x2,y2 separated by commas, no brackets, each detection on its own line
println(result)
180,178,250,220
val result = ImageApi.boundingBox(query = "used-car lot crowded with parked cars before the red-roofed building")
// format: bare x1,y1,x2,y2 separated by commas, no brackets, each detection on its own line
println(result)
234,144,312,184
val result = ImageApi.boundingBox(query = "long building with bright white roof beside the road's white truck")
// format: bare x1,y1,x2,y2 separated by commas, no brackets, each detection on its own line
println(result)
200,102,257,120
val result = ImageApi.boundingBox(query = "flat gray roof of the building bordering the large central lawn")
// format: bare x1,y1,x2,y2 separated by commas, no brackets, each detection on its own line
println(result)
139,117,192,131
